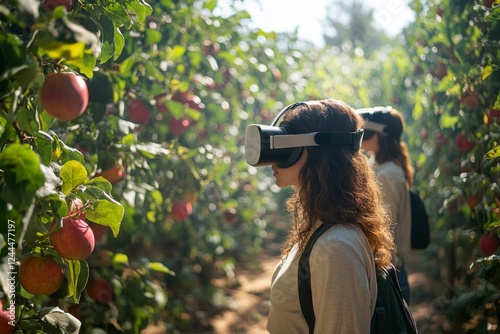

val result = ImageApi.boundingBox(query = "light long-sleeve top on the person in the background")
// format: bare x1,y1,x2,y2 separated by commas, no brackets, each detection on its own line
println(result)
377,161,411,258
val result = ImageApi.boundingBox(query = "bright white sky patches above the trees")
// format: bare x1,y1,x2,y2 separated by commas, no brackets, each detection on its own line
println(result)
225,0,414,45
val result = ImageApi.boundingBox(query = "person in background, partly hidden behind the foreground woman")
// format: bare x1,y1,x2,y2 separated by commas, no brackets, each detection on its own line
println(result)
358,107,413,304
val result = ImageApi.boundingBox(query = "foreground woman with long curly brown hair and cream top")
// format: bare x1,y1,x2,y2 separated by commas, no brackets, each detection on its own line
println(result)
258,99,394,334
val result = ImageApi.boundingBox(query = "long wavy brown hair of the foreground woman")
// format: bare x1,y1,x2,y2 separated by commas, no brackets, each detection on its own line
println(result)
283,99,395,267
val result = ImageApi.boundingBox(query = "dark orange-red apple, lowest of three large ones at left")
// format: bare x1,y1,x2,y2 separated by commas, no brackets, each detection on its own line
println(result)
18,254,64,296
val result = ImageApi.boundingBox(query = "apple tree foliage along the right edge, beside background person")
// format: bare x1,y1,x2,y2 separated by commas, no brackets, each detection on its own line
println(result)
407,1,500,333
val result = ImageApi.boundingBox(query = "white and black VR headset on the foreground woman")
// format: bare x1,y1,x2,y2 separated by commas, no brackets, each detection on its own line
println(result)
245,102,364,168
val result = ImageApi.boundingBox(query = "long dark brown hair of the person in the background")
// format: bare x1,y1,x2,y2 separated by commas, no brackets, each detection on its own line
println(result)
375,109,413,187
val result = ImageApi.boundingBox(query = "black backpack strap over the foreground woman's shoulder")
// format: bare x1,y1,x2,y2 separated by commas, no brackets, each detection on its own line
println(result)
298,223,332,334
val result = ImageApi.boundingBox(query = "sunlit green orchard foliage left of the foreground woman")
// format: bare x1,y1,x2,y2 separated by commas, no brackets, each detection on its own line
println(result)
0,0,308,333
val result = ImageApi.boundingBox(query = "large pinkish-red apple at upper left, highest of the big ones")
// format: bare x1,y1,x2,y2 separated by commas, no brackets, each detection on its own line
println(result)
40,72,89,121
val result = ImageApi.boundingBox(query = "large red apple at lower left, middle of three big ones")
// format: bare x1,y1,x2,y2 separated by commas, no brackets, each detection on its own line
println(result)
49,217,95,261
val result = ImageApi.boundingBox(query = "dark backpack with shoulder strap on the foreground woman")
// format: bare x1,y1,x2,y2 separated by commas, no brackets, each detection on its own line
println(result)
298,223,418,334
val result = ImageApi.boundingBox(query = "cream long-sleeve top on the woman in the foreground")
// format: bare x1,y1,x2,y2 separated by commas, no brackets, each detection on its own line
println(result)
267,225,377,334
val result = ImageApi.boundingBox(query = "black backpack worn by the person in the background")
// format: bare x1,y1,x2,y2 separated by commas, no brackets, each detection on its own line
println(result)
410,190,430,249
